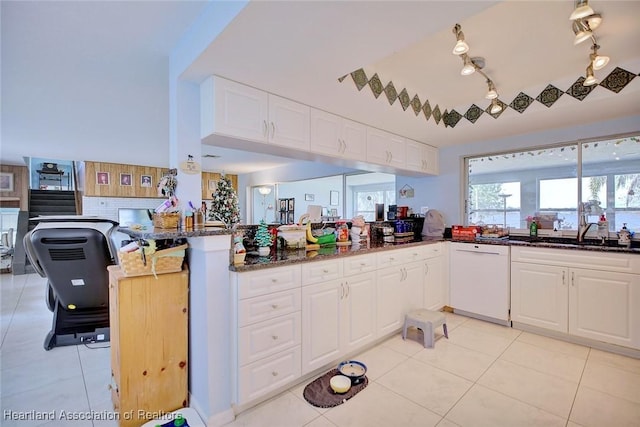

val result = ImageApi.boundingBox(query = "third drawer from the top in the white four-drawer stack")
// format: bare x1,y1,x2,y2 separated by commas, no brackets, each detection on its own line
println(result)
238,311,301,366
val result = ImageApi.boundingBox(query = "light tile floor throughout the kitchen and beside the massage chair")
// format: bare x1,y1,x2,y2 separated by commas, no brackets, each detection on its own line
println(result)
0,274,640,427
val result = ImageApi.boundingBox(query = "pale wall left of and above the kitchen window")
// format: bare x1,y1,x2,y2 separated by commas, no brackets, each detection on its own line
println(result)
396,116,640,226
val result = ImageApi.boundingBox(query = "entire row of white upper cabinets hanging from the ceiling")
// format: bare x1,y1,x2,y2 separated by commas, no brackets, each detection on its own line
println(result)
200,76,438,175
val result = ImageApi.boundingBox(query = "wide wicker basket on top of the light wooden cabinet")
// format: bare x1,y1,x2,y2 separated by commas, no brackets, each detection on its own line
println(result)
118,245,189,276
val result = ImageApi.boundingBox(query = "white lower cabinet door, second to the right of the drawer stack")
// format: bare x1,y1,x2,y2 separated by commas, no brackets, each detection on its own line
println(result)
340,273,376,354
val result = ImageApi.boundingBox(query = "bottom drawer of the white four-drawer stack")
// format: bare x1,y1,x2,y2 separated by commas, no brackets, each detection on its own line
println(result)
238,346,301,404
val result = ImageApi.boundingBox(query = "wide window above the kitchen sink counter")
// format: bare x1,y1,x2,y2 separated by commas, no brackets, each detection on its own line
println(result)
465,135,640,231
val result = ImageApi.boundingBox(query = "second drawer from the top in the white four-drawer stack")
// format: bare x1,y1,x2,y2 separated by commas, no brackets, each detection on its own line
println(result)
238,289,300,326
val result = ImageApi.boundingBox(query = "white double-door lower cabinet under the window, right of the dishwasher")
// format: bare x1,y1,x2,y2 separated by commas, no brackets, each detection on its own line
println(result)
511,248,640,349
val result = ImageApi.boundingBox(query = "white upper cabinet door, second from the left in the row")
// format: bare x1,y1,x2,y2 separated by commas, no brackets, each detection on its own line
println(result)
269,95,310,151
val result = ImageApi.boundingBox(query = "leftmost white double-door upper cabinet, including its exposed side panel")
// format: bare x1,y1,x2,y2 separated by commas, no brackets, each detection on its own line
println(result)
200,76,310,151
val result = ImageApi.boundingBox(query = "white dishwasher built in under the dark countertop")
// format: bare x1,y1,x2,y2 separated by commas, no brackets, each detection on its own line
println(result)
450,242,511,324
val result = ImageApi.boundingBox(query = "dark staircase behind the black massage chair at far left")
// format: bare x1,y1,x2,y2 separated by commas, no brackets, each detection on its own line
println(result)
12,190,77,275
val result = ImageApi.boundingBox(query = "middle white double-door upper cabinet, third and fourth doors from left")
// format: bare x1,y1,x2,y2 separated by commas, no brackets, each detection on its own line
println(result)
311,108,367,161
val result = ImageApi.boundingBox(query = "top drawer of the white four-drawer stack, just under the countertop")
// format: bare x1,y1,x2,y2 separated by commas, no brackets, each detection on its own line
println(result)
237,265,300,299
